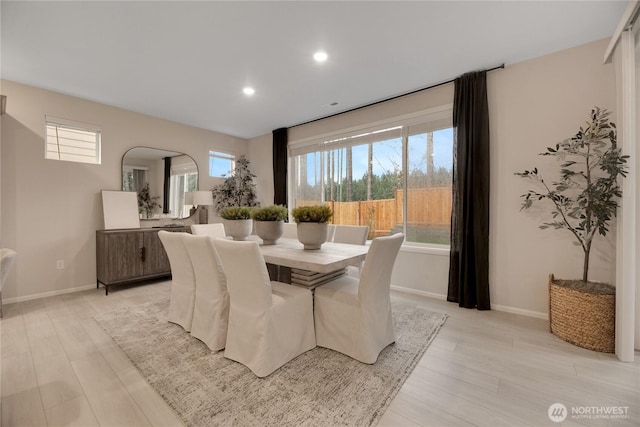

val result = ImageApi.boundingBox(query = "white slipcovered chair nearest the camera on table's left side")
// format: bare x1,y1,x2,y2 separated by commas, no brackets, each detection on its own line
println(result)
214,239,316,377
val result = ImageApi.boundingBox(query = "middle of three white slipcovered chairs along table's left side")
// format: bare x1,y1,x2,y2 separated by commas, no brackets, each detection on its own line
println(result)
182,233,229,351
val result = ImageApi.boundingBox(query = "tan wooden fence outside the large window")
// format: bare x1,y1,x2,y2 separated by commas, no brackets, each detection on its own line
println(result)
296,187,451,238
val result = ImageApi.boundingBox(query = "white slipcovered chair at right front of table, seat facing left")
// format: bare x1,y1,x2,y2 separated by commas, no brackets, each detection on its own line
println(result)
314,233,404,364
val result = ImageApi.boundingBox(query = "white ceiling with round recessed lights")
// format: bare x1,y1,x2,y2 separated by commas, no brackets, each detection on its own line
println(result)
0,0,627,138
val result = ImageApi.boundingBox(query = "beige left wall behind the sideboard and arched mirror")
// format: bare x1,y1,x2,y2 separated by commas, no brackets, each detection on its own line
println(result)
0,80,247,302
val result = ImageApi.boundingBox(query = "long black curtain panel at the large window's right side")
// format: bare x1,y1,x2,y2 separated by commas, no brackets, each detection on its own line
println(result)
447,71,491,310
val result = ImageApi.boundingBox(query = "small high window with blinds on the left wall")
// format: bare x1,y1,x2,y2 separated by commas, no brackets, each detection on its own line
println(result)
45,117,100,165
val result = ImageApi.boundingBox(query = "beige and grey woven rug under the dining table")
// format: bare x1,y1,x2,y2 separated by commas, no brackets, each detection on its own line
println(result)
95,300,447,427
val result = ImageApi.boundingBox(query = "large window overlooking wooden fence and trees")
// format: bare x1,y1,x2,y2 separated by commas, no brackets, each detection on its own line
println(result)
290,108,453,245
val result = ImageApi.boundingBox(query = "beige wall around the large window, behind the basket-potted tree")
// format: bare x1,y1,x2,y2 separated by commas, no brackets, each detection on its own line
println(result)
249,40,615,317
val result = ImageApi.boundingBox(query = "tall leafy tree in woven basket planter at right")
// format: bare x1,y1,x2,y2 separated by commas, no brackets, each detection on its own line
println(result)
516,107,628,353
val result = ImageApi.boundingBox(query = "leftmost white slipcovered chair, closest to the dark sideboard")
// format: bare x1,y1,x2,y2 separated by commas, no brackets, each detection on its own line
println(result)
158,230,196,332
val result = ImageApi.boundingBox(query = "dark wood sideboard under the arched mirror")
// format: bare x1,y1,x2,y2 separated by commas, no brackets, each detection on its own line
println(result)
96,227,190,295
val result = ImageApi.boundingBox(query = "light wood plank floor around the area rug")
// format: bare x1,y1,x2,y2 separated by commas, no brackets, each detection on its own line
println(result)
0,282,640,427
